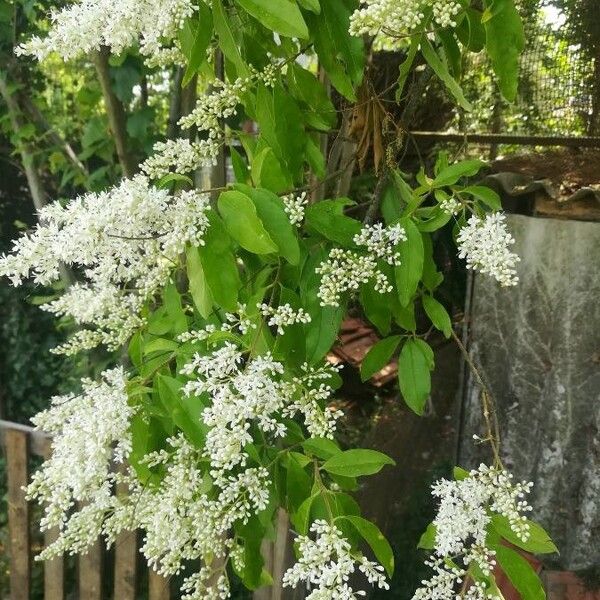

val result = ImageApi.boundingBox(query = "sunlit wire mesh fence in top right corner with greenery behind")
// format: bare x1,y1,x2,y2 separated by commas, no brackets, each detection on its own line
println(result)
452,0,600,137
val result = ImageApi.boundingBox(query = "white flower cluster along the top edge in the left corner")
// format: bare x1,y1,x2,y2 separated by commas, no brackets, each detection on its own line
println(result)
19,0,197,64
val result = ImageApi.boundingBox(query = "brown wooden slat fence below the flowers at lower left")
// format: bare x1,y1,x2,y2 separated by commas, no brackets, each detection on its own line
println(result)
0,420,170,600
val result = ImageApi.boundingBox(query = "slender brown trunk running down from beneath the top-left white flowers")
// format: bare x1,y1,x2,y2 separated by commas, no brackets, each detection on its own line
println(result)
93,48,137,177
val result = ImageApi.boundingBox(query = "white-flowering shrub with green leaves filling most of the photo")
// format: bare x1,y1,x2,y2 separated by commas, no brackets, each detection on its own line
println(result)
0,0,548,600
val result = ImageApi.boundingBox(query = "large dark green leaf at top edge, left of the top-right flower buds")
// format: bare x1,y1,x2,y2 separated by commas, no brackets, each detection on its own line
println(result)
306,0,365,101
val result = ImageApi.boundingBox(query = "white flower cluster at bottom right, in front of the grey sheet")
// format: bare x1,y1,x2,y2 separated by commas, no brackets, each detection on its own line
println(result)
413,465,533,600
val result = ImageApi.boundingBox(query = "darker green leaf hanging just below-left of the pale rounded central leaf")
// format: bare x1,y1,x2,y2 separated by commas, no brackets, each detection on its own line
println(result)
198,211,241,312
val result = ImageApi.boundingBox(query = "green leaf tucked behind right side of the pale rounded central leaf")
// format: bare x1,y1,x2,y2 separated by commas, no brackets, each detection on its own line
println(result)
235,185,300,265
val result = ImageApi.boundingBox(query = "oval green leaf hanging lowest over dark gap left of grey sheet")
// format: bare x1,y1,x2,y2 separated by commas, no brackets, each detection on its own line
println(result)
398,340,431,415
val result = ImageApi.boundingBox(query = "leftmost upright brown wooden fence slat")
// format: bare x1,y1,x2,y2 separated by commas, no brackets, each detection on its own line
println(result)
4,429,31,600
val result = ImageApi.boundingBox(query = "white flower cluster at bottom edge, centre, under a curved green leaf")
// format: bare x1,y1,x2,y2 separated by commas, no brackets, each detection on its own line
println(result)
283,520,389,600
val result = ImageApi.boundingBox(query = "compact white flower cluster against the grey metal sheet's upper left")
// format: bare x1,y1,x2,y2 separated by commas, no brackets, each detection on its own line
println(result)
456,213,521,287
